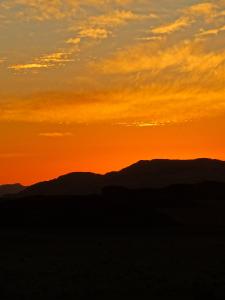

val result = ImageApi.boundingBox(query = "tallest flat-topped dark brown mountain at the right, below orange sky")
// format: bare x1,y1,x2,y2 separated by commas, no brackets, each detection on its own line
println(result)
106,158,225,188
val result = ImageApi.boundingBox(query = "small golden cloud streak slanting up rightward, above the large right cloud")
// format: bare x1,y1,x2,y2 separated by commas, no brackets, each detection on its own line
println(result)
151,17,193,34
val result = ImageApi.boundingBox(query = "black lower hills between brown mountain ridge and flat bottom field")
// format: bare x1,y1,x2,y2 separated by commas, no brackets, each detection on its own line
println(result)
0,182,225,231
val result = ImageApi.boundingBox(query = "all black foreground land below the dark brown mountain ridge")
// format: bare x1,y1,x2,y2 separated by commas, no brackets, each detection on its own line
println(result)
0,182,225,300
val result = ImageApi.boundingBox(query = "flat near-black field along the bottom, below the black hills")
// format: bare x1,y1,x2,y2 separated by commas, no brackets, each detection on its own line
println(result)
0,232,225,299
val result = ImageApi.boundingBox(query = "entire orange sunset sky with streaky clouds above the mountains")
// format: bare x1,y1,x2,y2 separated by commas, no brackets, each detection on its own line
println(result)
0,0,225,184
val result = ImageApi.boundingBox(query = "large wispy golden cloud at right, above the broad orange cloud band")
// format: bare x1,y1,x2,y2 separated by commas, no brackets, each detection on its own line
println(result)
96,41,225,74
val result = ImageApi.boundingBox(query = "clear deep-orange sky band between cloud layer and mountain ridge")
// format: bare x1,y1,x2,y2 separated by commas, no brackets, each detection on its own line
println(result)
0,118,225,184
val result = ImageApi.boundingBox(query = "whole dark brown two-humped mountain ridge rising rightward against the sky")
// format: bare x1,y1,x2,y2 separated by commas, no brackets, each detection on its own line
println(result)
19,158,225,196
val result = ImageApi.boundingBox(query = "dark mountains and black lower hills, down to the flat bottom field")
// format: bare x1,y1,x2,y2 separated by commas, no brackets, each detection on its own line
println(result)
0,159,225,231
